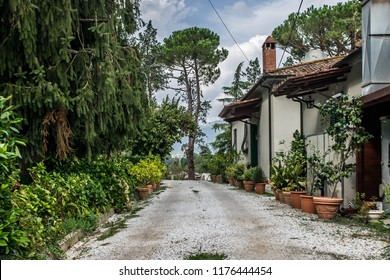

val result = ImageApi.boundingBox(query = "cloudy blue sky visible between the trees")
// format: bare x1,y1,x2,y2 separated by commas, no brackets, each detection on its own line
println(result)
141,0,347,154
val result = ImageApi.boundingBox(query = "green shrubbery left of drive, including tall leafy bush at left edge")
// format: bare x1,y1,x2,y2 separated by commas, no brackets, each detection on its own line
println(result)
0,96,164,259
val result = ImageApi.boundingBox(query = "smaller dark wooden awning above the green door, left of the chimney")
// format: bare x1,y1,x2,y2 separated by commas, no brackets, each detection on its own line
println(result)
218,98,261,122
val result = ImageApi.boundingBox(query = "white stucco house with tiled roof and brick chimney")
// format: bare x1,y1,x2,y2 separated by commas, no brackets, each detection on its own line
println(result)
220,0,390,208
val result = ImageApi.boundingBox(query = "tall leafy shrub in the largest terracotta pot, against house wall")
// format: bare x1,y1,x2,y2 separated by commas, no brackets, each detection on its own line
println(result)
313,95,371,219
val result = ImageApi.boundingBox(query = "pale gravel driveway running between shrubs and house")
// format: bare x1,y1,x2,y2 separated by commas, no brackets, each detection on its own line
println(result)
67,181,389,260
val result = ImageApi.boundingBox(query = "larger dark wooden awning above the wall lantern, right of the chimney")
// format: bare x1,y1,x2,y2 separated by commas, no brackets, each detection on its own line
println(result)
273,67,351,98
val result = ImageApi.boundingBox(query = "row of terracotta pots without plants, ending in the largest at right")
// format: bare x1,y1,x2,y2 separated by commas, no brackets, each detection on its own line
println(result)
275,190,343,219
